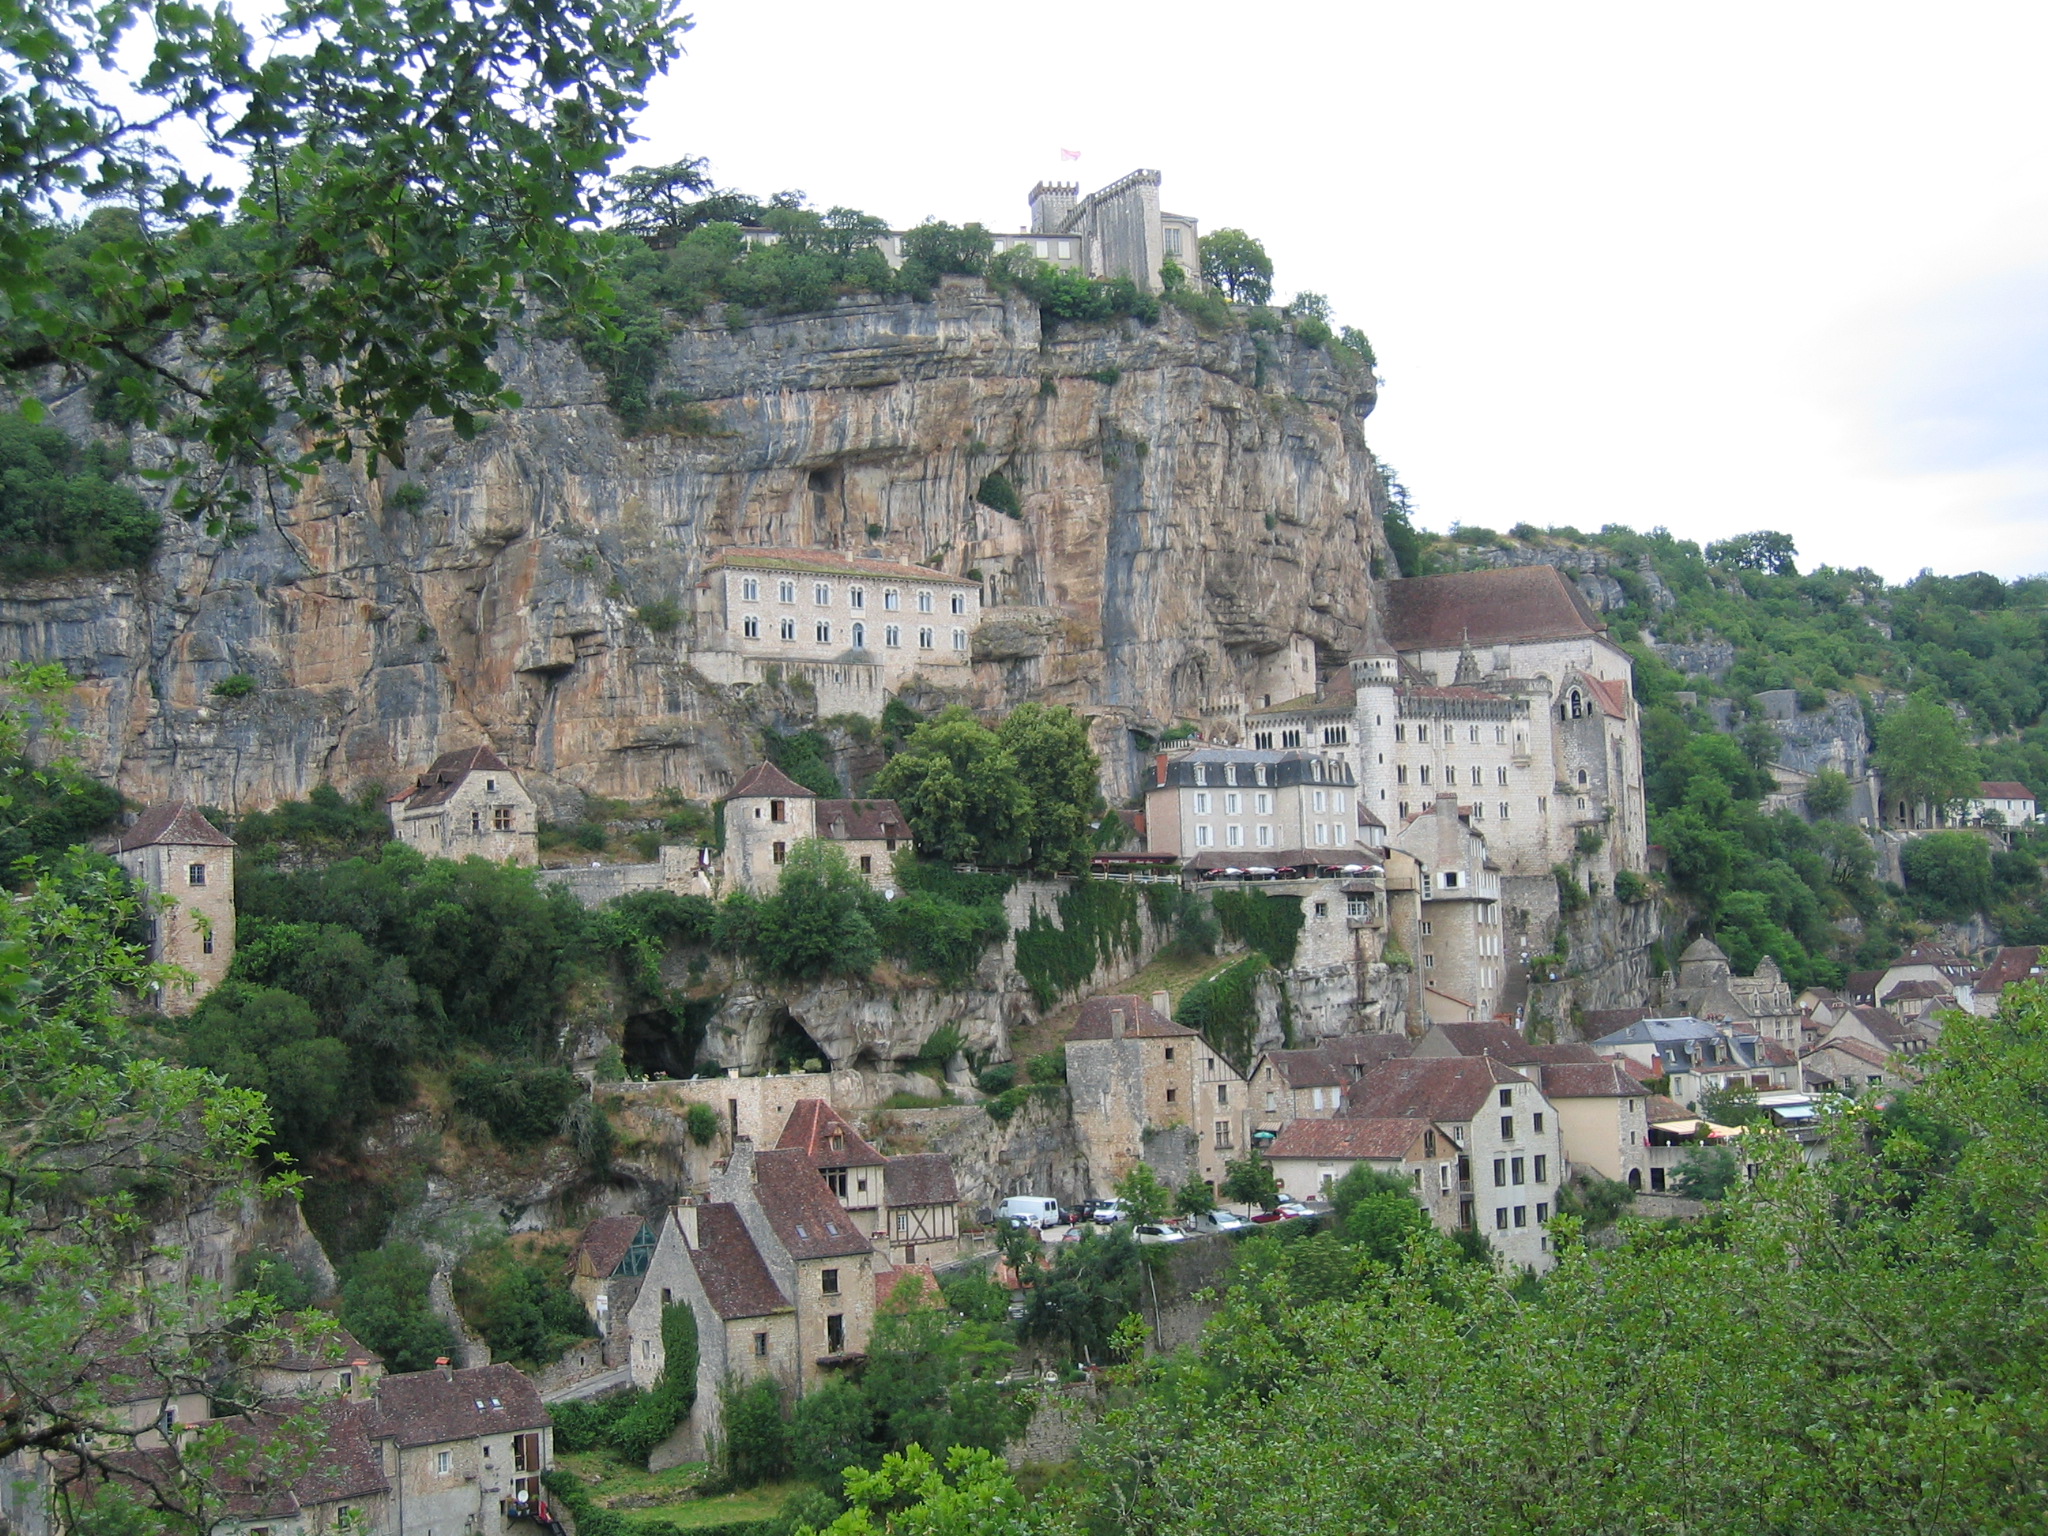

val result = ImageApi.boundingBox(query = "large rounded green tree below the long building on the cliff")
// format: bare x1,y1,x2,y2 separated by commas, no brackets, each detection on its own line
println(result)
872,705,1034,864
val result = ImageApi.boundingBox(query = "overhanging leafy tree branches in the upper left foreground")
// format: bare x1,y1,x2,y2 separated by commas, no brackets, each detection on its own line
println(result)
0,0,686,520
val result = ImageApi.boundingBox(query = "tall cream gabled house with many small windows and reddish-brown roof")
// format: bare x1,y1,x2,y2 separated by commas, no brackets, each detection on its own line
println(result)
1348,1057,1565,1274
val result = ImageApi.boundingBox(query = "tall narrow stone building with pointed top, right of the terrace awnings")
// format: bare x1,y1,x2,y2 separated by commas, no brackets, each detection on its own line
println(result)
1393,791,1507,1024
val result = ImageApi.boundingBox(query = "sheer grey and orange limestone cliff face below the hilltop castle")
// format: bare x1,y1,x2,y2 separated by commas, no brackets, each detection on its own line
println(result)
0,281,1382,815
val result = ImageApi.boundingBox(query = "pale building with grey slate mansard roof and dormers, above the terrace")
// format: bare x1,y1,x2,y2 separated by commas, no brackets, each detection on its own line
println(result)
1145,748,1364,864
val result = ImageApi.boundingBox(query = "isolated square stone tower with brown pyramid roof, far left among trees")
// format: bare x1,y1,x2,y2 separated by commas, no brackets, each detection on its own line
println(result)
115,801,236,1014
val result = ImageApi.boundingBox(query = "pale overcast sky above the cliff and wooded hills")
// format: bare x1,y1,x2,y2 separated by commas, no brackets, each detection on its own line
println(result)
633,0,2048,580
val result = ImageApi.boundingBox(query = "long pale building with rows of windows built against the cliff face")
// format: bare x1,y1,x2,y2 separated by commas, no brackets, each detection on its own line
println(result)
690,548,981,717
